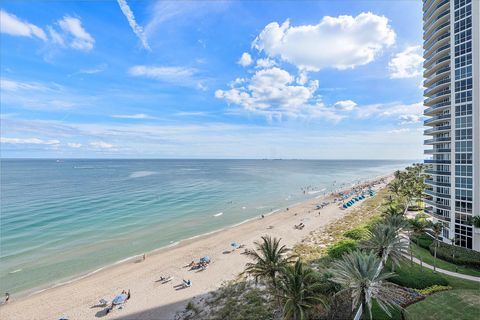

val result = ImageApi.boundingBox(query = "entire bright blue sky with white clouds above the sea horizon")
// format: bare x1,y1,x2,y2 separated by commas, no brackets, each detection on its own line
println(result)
0,0,423,159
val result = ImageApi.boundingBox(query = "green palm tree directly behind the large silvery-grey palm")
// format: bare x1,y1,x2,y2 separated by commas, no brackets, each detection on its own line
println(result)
361,224,408,267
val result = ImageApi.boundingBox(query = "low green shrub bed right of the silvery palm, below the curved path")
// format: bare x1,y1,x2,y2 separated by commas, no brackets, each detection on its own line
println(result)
389,262,448,289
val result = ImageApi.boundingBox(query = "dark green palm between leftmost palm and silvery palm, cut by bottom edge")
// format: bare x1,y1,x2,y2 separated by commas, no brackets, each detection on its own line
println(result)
279,260,325,320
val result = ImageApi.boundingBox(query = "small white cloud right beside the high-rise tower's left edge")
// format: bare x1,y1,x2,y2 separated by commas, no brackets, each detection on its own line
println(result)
388,46,423,79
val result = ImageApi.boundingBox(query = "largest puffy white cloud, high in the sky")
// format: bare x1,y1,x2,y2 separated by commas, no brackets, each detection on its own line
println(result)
252,12,396,71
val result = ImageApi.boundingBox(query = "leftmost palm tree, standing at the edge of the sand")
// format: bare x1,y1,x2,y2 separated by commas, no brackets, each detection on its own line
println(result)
244,236,288,304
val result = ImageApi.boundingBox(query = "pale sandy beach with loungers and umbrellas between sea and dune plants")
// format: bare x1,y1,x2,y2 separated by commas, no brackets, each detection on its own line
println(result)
0,179,388,319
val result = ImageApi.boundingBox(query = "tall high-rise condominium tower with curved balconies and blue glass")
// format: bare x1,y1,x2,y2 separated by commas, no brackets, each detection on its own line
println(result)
423,0,480,251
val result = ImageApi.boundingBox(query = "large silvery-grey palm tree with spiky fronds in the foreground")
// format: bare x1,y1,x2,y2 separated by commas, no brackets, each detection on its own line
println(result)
332,251,396,319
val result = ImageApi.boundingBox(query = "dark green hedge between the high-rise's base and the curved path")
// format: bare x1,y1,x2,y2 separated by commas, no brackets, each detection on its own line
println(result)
429,242,480,269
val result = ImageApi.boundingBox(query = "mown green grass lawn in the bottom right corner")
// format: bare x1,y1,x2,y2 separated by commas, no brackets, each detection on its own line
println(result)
407,289,480,320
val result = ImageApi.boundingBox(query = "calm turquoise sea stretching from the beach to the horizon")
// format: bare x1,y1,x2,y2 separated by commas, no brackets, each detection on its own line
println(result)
0,160,411,294
